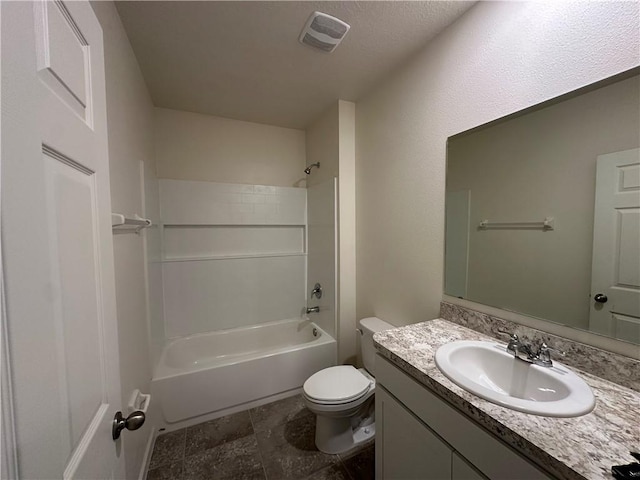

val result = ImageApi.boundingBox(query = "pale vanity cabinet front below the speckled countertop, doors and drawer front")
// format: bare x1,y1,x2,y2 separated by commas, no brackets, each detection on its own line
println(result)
376,355,553,480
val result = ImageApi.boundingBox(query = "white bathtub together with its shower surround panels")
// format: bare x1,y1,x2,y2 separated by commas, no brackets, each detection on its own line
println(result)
152,179,337,429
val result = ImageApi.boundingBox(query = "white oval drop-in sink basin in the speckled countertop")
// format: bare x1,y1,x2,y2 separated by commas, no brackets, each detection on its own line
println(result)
435,341,595,417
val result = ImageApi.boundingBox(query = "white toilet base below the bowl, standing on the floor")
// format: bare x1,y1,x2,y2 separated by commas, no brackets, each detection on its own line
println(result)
316,415,376,455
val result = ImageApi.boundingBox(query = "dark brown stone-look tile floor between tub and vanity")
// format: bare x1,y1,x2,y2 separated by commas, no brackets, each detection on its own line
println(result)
147,395,374,480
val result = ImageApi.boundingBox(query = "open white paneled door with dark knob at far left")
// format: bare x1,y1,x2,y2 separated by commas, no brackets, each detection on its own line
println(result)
0,1,124,479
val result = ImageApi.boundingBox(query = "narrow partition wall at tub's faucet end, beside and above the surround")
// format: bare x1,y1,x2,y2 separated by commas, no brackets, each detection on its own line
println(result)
306,100,357,364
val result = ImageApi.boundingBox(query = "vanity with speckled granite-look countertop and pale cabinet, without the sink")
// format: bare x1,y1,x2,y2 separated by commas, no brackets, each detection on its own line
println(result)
374,319,640,480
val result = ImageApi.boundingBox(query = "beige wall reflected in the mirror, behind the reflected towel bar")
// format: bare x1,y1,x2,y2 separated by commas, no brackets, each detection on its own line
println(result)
447,76,640,329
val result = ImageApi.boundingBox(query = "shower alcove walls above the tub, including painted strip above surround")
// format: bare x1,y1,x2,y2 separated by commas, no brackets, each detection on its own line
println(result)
149,108,337,352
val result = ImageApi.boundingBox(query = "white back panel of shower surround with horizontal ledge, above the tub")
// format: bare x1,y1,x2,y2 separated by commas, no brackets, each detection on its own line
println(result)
160,179,307,338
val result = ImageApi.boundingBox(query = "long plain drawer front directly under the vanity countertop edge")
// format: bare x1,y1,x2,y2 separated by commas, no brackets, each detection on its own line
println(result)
375,355,553,480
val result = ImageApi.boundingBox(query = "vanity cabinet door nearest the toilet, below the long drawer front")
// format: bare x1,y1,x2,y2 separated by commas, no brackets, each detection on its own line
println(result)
376,388,452,480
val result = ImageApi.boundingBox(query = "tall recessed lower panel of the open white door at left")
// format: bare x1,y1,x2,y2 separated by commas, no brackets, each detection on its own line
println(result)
43,147,105,446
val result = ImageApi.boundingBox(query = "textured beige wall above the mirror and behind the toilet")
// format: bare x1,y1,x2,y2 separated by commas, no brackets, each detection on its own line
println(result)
356,2,640,348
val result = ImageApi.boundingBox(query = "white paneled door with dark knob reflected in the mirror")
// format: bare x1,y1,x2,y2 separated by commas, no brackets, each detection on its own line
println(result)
589,148,640,343
